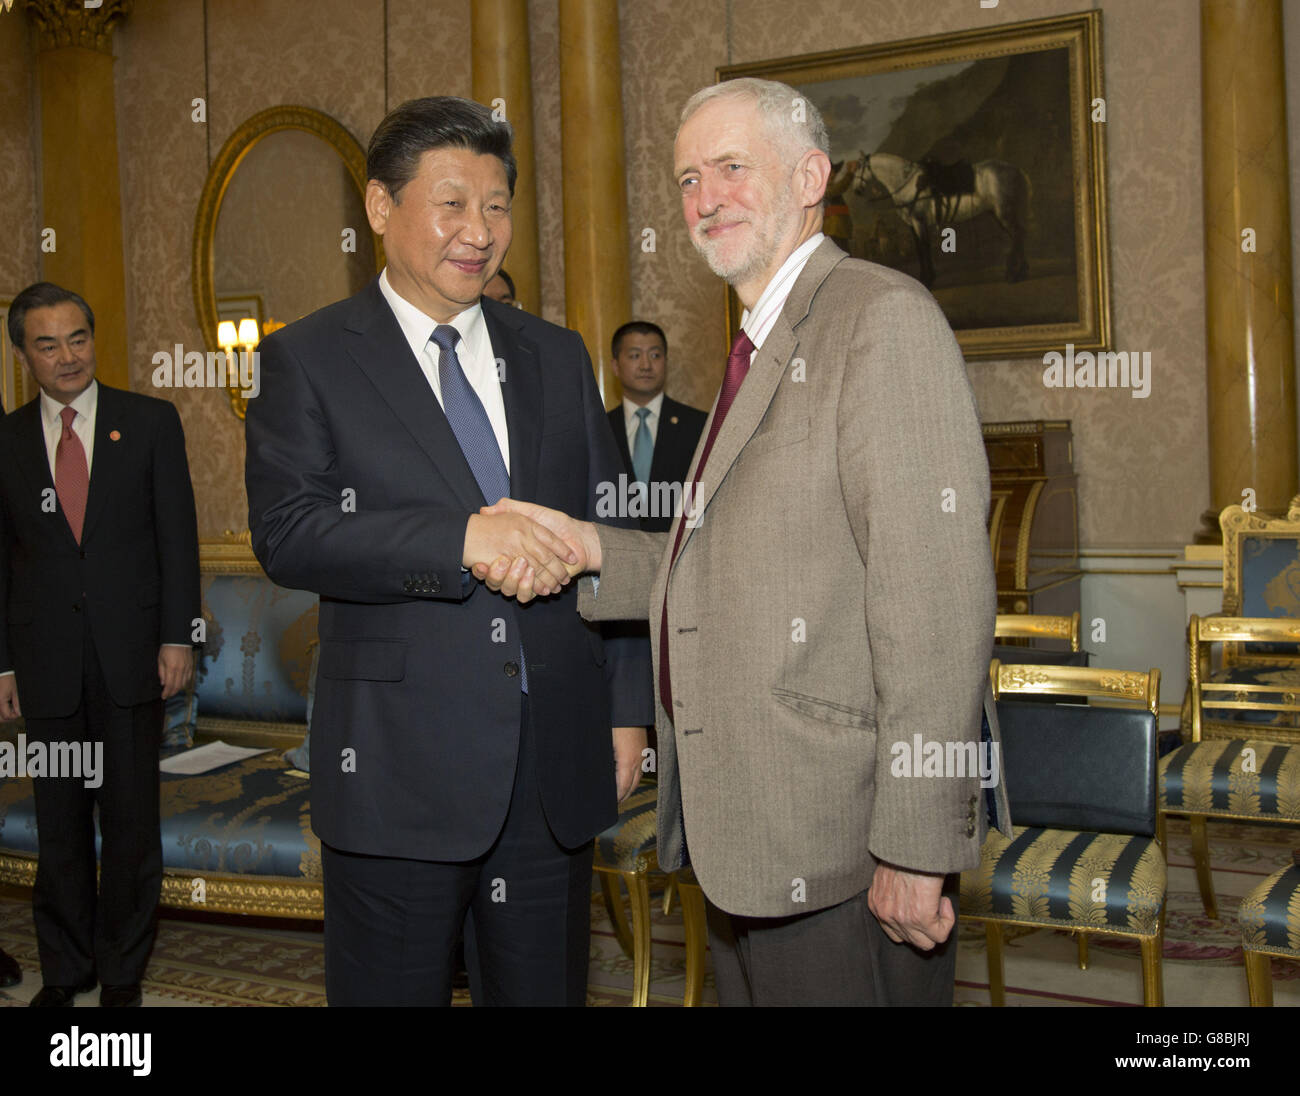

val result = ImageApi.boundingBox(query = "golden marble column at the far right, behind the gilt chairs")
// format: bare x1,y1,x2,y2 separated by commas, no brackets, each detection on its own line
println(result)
1197,0,1296,541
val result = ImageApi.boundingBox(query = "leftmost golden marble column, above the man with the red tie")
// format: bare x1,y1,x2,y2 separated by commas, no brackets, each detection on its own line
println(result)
27,0,131,389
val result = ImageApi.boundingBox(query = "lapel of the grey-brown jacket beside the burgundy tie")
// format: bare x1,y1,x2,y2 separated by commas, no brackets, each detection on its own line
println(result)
672,239,846,556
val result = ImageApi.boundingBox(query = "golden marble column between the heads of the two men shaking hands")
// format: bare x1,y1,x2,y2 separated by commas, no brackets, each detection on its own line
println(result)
560,0,631,395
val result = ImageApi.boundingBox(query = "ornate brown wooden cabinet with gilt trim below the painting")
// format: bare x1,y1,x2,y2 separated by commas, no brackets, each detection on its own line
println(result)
984,421,1082,615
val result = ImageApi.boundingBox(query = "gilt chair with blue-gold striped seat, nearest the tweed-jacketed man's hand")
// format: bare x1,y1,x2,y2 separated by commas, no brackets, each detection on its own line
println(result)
961,662,1166,1005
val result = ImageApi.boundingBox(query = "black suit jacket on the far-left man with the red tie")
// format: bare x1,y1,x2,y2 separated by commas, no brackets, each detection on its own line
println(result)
0,382,199,719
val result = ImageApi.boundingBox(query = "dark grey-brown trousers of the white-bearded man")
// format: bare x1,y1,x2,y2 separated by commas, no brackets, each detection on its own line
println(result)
705,875,958,1006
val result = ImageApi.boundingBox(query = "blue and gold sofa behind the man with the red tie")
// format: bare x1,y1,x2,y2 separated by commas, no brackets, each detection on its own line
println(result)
0,533,324,919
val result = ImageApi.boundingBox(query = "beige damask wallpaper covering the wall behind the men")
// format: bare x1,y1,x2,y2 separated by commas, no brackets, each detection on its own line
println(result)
0,0,1258,549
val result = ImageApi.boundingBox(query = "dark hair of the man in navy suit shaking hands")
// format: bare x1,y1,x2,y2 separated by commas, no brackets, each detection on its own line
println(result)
365,95,519,200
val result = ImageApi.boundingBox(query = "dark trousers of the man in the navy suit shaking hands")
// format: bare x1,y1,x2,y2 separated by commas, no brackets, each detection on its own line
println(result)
321,697,595,1006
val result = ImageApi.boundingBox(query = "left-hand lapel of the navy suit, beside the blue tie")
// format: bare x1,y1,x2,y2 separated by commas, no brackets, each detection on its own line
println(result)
343,278,484,514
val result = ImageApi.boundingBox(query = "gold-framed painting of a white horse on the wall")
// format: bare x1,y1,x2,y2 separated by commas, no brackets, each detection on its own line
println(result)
718,12,1110,359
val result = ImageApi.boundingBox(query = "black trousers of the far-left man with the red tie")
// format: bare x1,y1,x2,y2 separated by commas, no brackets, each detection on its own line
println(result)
26,629,163,985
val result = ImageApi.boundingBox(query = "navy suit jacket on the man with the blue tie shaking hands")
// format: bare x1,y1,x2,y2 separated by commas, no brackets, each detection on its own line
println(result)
246,278,653,861
